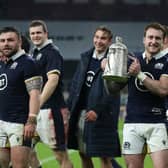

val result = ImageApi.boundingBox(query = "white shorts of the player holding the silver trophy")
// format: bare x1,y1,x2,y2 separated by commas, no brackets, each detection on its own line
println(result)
122,123,168,154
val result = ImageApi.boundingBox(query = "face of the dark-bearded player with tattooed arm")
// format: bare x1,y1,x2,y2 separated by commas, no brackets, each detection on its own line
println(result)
0,32,21,58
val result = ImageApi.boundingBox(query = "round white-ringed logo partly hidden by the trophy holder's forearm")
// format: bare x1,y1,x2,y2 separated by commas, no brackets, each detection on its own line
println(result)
135,72,154,92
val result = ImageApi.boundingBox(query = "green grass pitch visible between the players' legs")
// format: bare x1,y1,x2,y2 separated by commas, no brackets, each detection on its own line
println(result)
36,121,153,168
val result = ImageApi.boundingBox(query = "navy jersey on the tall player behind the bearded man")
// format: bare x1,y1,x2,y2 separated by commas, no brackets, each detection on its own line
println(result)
32,40,64,108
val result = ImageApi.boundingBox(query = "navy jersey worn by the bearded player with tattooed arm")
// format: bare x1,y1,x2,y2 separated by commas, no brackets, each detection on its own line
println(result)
0,50,38,123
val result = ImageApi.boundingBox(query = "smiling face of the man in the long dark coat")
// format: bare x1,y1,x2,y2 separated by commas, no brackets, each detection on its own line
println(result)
93,30,111,54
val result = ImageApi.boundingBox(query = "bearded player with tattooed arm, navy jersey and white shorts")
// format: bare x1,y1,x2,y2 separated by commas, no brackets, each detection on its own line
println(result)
0,27,42,168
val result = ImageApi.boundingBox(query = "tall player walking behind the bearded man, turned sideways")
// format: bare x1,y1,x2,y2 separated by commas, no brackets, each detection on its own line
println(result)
29,20,73,168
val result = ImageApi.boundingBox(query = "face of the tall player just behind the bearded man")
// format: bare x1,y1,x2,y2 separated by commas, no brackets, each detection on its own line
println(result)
29,25,48,47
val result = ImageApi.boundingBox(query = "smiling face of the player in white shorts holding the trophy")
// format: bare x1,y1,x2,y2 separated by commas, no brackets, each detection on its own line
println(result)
143,28,163,56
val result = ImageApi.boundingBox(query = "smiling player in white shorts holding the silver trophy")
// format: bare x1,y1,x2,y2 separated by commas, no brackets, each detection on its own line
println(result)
105,23,168,168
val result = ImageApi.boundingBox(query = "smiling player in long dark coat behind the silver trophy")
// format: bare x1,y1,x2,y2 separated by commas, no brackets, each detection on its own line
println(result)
68,26,121,168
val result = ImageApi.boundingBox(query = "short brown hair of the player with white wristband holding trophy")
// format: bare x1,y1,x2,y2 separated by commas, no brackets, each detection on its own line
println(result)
144,22,166,39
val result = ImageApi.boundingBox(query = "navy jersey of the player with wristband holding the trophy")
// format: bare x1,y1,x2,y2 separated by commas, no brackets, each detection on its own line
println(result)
125,53,168,123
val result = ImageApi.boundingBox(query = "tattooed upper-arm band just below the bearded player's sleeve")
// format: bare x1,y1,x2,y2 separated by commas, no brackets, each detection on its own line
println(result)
25,76,43,92
